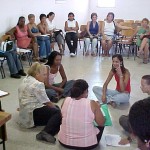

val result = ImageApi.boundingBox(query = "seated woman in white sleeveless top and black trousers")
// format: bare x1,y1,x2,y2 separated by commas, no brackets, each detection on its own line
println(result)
65,12,79,57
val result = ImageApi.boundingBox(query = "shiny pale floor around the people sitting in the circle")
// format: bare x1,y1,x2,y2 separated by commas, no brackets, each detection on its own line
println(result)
0,44,150,150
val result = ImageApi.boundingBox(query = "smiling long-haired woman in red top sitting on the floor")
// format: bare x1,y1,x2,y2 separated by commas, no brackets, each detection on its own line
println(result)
93,54,131,107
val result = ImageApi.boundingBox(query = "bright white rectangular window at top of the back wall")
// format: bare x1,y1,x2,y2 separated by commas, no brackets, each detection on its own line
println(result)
98,0,115,7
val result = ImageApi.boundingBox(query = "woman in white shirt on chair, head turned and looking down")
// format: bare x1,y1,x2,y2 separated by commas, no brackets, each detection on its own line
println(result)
47,12,64,54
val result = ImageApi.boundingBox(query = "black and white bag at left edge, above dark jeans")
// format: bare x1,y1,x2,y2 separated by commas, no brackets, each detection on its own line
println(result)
0,40,14,53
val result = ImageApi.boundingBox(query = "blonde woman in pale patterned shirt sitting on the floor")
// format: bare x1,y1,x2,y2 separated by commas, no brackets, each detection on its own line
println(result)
18,62,61,143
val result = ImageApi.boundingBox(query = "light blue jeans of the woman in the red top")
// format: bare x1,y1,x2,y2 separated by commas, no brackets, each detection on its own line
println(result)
93,86,130,104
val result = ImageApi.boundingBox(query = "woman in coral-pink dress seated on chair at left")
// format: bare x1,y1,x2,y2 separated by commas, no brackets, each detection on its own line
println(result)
6,16,39,61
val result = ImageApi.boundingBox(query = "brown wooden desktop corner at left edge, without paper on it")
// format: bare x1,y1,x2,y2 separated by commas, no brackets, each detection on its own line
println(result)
0,111,11,127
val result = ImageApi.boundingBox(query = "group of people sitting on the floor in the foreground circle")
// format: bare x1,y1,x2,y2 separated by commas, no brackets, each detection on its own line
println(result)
18,51,150,150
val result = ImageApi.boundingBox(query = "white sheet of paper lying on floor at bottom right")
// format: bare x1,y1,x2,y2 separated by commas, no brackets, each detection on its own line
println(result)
105,134,130,147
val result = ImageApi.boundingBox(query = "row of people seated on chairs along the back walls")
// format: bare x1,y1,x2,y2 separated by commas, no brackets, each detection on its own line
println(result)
0,12,150,78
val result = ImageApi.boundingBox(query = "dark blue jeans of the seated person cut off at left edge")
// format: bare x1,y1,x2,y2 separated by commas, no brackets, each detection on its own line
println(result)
0,50,23,74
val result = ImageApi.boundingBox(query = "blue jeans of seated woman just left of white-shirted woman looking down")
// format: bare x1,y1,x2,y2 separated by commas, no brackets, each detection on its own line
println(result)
37,37,51,58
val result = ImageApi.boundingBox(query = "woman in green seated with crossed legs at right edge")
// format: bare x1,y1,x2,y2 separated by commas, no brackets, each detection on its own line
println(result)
130,18,150,64
